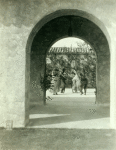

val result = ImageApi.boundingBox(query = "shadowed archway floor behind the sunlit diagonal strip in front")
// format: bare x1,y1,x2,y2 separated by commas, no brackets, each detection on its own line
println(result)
28,97,110,126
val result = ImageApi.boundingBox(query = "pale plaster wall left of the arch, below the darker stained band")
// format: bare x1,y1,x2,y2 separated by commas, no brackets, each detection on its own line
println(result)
0,25,29,127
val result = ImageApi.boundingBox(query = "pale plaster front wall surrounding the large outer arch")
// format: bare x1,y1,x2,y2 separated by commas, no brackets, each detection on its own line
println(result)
0,0,116,128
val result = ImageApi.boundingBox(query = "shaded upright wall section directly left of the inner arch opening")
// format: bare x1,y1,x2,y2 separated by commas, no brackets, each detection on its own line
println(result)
28,53,46,105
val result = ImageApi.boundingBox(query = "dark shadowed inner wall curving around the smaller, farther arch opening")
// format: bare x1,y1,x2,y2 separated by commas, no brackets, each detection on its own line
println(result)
30,15,110,104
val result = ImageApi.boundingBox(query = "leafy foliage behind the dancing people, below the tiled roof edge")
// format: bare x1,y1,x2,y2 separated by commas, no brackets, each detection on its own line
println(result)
46,54,96,87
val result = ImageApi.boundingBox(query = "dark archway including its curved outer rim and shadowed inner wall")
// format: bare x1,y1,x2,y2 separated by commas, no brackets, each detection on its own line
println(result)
26,10,110,108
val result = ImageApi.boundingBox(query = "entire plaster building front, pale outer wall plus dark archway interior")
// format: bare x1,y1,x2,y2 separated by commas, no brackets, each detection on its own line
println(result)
0,0,116,129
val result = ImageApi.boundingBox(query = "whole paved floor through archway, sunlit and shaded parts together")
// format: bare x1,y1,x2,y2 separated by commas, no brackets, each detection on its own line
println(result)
28,89,110,129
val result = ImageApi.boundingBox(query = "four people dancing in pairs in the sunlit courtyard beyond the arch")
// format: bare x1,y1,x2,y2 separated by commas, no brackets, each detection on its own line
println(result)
51,69,88,95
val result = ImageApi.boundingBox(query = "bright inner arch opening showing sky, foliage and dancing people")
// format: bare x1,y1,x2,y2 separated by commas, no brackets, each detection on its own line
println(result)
46,37,97,103
